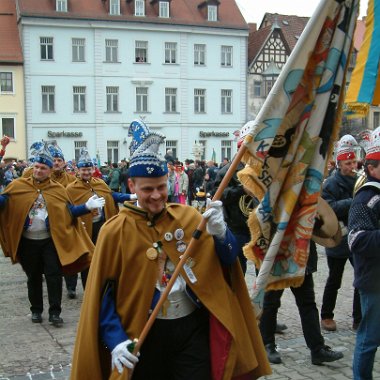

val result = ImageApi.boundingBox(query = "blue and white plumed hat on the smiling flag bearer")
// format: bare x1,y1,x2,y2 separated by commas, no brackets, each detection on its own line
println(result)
128,120,168,177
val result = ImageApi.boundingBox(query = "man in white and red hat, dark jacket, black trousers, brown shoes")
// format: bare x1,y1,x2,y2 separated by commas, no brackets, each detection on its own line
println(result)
321,135,361,331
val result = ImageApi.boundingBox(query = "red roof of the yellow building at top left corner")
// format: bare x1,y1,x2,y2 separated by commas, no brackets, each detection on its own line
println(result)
0,0,23,64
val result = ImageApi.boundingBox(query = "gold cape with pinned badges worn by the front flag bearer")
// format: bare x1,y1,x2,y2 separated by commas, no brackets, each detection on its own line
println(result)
71,202,271,380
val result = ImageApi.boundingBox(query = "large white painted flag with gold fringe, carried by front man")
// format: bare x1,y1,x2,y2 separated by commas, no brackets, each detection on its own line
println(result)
239,0,359,314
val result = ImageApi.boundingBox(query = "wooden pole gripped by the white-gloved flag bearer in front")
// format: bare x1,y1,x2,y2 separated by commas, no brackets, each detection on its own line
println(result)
129,144,247,378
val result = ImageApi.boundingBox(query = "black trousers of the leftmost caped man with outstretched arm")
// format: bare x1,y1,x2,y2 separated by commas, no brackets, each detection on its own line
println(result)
17,238,62,315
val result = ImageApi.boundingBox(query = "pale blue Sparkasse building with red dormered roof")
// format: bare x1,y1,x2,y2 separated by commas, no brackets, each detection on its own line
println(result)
17,0,248,162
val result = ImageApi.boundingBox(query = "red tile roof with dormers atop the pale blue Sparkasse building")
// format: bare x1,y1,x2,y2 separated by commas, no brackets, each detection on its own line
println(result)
16,0,248,29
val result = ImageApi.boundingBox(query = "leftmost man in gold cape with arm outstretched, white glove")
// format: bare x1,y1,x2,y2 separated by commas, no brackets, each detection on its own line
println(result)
0,142,104,327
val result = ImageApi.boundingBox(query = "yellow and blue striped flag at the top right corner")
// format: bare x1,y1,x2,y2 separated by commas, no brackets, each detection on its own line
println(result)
345,0,380,117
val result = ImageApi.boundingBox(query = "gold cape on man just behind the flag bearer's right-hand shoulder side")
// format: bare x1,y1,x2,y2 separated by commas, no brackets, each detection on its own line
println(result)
66,178,119,237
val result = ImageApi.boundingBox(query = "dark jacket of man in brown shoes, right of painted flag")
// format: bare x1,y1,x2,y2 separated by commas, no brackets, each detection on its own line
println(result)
322,170,356,258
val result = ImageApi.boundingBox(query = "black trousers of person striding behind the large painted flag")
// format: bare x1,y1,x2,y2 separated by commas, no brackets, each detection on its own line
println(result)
260,273,325,352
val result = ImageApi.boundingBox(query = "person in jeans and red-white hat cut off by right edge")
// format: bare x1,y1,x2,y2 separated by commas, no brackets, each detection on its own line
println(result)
348,127,380,380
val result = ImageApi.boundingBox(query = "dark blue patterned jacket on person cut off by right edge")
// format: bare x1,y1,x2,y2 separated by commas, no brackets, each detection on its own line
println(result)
348,177,380,292
